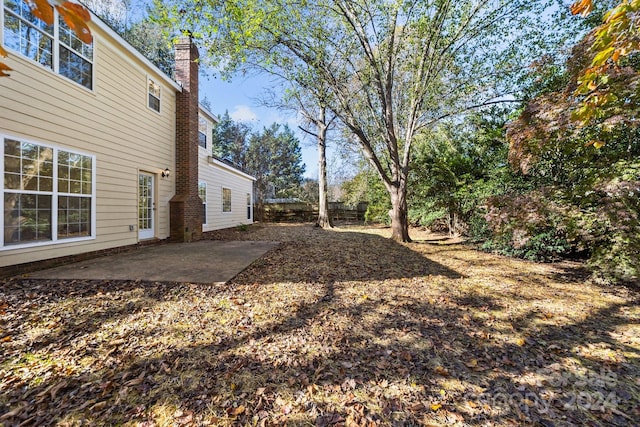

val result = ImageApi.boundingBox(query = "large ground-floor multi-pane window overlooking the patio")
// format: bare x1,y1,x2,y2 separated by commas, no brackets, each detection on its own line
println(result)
0,138,95,247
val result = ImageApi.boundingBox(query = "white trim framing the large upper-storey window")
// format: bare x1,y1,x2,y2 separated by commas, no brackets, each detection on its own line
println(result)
0,0,97,92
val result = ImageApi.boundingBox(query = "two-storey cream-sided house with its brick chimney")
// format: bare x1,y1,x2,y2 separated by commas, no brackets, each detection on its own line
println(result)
0,0,254,274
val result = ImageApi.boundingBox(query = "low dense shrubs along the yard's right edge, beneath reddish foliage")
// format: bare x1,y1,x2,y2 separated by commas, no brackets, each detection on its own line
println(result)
482,171,640,283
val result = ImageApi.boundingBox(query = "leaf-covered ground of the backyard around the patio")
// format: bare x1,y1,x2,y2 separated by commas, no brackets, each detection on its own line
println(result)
0,224,640,426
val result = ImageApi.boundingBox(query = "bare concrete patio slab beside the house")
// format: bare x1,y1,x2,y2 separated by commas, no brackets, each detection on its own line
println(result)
27,240,278,283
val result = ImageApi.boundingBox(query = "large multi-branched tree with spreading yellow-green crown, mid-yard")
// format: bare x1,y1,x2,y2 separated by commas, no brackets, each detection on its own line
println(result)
161,0,550,241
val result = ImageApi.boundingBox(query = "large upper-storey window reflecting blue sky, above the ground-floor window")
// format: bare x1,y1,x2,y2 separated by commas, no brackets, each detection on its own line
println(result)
3,0,93,89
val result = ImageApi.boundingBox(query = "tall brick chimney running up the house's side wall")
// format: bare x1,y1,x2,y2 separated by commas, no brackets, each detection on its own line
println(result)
169,37,202,242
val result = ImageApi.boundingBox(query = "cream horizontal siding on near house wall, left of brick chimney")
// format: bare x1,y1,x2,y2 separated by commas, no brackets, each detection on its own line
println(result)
0,20,176,267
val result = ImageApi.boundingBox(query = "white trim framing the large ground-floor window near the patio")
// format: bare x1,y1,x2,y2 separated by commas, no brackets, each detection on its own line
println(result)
0,133,97,252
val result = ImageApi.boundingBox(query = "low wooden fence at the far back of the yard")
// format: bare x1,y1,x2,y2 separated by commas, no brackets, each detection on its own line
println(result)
263,202,369,222
